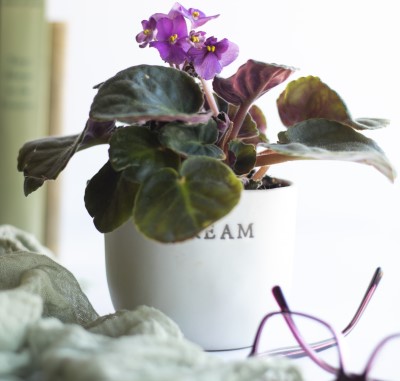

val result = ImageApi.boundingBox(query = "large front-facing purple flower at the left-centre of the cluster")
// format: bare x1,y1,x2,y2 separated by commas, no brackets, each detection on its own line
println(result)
150,15,191,65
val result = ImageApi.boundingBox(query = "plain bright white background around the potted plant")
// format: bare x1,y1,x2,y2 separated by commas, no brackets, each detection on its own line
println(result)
49,0,400,369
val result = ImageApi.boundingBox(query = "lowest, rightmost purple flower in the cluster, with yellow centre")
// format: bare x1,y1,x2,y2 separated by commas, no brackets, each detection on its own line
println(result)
188,37,239,79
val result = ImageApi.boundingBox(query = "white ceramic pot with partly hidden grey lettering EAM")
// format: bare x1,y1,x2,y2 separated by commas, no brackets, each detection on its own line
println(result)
105,185,296,350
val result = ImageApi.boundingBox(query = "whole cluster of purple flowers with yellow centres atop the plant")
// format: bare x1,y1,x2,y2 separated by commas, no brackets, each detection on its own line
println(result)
136,3,239,80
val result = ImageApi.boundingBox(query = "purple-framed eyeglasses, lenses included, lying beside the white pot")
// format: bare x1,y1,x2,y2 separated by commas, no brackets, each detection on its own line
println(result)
249,268,400,381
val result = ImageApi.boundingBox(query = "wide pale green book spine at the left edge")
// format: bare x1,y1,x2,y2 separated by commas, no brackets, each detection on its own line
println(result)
0,0,50,240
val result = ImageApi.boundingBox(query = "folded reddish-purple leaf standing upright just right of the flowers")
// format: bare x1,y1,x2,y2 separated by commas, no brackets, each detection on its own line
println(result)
213,60,294,106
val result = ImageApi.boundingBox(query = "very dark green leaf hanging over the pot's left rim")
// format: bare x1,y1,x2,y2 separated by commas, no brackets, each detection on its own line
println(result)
85,162,139,233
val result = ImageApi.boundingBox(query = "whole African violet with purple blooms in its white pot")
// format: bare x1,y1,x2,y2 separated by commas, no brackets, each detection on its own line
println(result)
18,3,395,349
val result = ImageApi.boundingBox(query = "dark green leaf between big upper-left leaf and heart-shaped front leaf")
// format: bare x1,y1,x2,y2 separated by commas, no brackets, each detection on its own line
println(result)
109,126,180,183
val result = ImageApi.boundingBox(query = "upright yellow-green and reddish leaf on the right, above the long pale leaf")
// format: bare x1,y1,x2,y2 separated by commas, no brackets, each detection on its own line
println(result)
277,76,388,130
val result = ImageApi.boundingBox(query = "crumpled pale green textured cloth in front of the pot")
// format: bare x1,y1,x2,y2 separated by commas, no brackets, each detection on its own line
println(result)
0,226,301,381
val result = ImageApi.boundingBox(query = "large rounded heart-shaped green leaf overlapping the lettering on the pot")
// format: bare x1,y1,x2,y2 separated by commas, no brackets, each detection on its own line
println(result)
134,156,242,242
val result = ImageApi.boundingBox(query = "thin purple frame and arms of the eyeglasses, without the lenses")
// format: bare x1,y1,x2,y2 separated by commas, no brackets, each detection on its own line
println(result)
249,267,400,381
